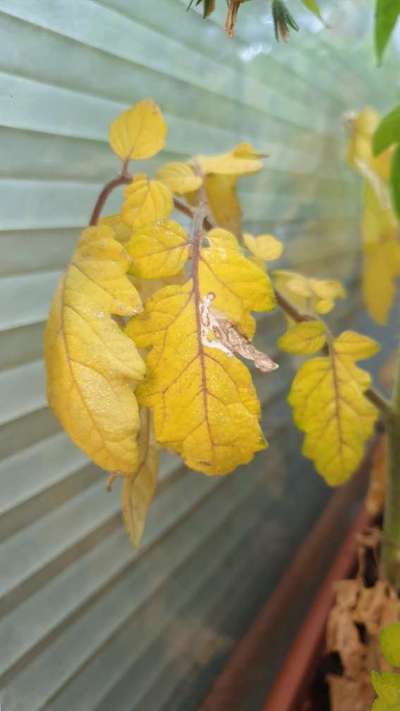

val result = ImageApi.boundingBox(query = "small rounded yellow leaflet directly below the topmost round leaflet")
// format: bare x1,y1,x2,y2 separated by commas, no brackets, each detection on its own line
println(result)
122,175,174,229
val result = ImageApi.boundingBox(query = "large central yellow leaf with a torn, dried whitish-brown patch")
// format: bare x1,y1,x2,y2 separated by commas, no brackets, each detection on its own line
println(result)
126,229,276,475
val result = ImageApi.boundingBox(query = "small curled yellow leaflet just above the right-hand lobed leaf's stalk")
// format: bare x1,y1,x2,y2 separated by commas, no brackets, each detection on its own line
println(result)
273,269,346,315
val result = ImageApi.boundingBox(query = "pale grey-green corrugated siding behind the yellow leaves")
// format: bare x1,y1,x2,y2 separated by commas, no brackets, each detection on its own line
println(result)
0,0,396,711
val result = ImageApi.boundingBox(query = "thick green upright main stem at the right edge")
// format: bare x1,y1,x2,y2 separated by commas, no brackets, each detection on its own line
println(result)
381,351,400,590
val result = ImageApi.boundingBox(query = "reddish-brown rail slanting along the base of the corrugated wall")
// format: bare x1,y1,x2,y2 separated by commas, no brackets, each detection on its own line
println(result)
264,508,371,711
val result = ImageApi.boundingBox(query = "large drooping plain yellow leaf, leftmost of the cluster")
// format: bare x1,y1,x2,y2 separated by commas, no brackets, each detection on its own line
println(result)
45,226,144,474
